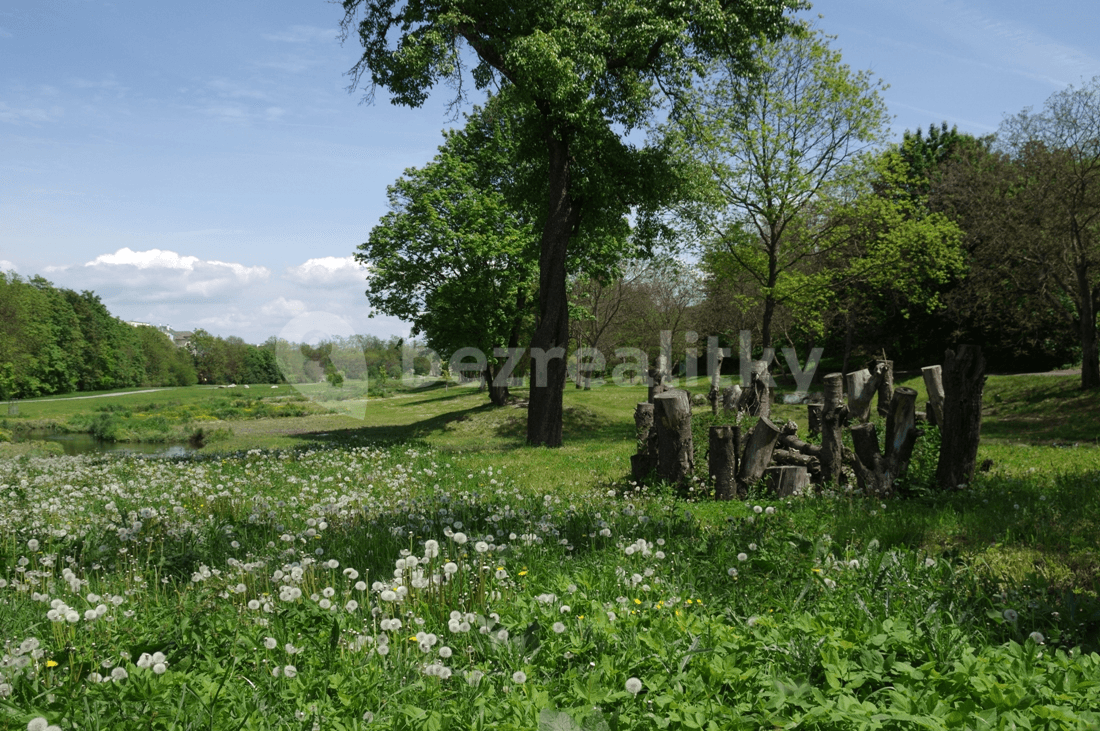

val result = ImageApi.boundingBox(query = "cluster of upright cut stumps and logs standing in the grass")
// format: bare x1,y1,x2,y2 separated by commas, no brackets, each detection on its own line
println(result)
630,345,985,500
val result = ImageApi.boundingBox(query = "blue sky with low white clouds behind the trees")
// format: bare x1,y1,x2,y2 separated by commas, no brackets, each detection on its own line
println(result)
0,0,1100,343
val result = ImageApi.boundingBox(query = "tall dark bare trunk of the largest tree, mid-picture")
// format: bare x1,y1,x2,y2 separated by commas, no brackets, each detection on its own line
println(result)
527,130,580,446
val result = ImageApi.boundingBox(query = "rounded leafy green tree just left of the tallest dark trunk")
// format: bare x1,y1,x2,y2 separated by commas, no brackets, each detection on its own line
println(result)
355,99,538,406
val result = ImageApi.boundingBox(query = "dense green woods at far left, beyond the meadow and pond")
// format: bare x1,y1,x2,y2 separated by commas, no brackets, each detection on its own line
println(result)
0,272,282,399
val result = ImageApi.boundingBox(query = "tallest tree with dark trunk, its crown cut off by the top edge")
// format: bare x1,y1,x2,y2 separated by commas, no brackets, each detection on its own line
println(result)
343,0,803,446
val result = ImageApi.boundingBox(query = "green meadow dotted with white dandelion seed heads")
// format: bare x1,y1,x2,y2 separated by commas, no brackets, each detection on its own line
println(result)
0,377,1100,730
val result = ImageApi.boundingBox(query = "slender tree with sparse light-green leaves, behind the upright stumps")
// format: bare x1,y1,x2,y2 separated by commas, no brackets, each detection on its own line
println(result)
673,31,889,347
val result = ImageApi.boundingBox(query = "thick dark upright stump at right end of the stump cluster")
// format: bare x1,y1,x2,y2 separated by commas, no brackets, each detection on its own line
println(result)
936,345,986,490
